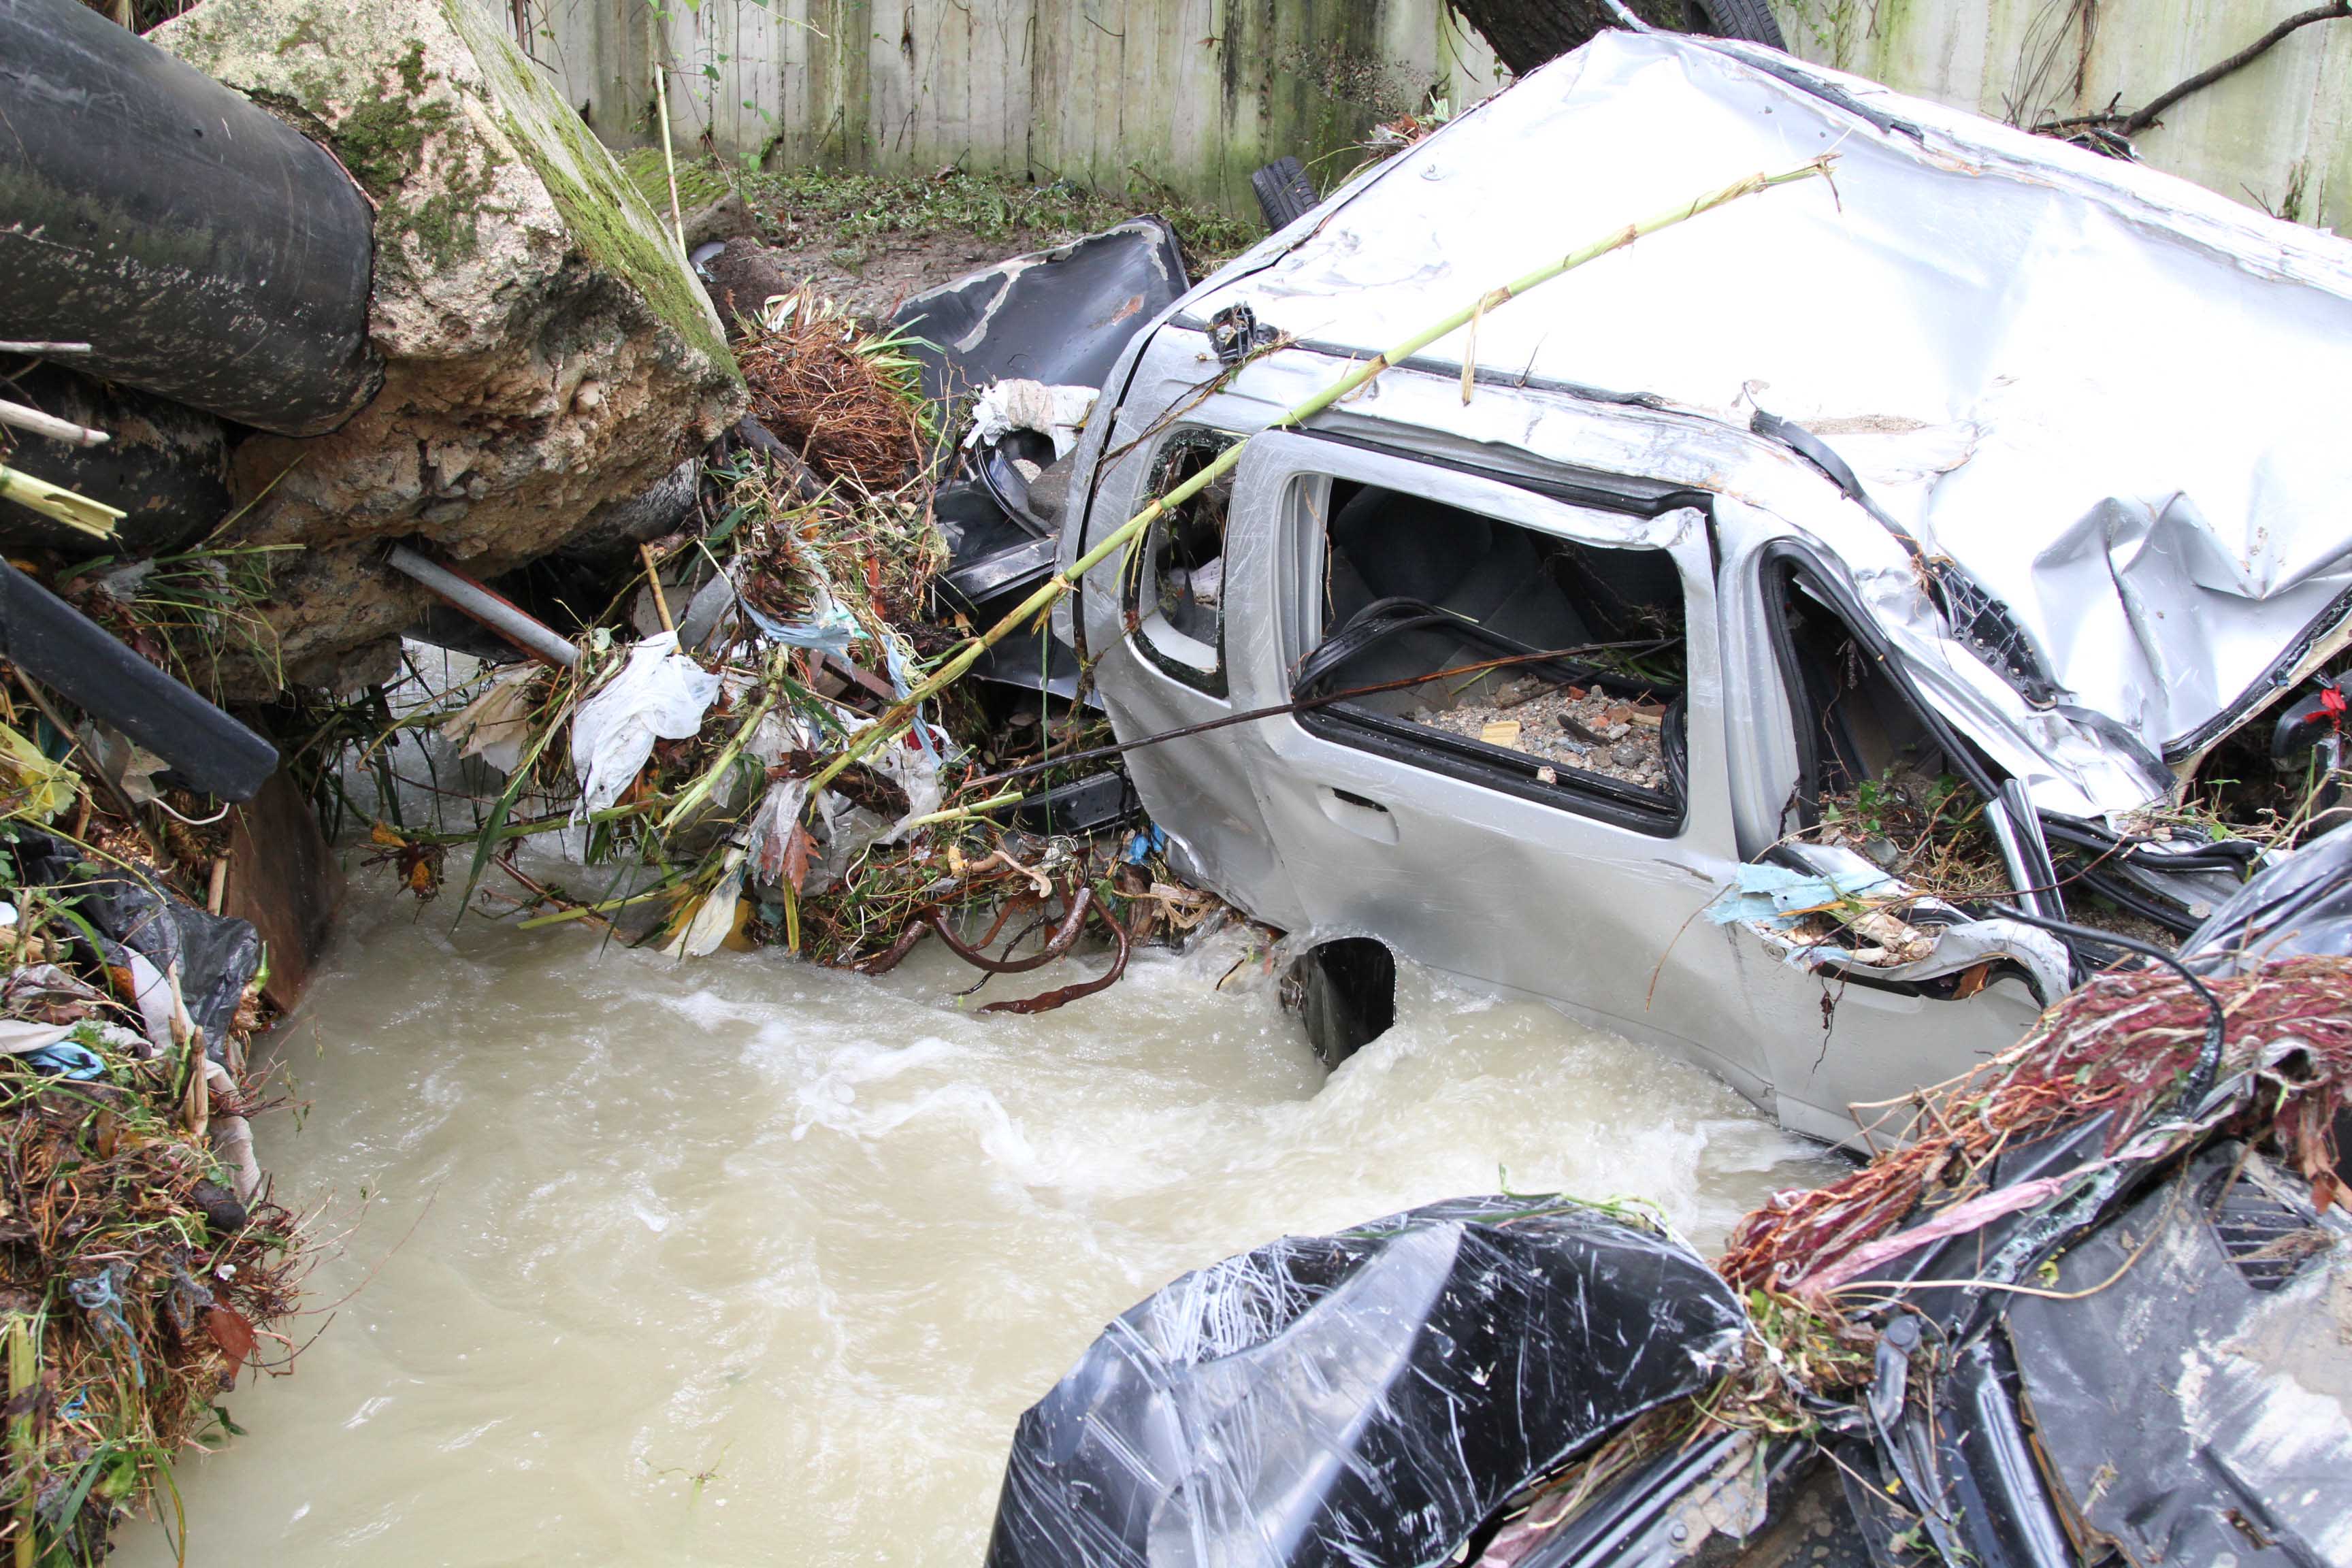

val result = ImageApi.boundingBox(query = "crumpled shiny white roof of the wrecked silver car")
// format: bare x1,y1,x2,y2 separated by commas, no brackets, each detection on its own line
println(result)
1181,33,2352,811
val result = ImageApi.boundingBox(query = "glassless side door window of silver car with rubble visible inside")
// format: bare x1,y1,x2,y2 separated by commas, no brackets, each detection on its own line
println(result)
1296,482,1684,818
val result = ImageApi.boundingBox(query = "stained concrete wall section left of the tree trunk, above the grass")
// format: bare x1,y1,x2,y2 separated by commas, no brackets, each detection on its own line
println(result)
522,0,1496,212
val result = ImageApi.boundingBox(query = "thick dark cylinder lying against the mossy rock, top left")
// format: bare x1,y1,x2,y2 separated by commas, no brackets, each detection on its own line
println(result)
0,0,383,435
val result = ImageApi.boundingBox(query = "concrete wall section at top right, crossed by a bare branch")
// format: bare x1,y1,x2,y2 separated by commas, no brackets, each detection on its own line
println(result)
1774,0,2352,228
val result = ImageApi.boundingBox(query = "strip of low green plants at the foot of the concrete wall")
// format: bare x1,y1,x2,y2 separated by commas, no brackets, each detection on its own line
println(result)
625,153,1265,275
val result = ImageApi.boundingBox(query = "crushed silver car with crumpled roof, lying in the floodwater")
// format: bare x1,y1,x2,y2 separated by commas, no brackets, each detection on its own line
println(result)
1056,33,2352,1140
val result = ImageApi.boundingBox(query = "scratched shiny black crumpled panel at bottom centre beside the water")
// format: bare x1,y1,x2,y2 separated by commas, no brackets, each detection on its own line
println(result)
988,1196,1745,1568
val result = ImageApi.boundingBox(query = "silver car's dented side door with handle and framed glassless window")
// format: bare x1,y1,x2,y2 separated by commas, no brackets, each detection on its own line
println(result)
1232,435,1771,1100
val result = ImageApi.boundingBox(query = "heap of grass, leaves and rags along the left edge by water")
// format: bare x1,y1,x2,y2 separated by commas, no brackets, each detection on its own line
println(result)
0,742,301,1563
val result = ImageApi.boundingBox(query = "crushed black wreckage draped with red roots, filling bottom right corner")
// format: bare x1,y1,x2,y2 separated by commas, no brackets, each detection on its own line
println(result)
988,832,2352,1568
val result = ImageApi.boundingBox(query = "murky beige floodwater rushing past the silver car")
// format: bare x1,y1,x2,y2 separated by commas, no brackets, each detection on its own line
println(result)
118,875,1835,1568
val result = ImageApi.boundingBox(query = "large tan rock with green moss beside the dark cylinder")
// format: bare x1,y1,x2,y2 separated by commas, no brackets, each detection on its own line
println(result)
150,0,743,689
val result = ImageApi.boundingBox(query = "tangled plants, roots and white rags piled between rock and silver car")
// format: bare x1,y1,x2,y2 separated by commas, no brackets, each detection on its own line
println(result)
333,199,1221,1011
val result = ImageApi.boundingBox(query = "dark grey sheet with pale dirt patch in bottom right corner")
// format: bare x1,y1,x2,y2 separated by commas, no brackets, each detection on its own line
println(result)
2006,1145,2352,1568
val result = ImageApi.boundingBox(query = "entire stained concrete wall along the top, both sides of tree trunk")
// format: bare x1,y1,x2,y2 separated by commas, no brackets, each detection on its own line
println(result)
529,0,2352,223
